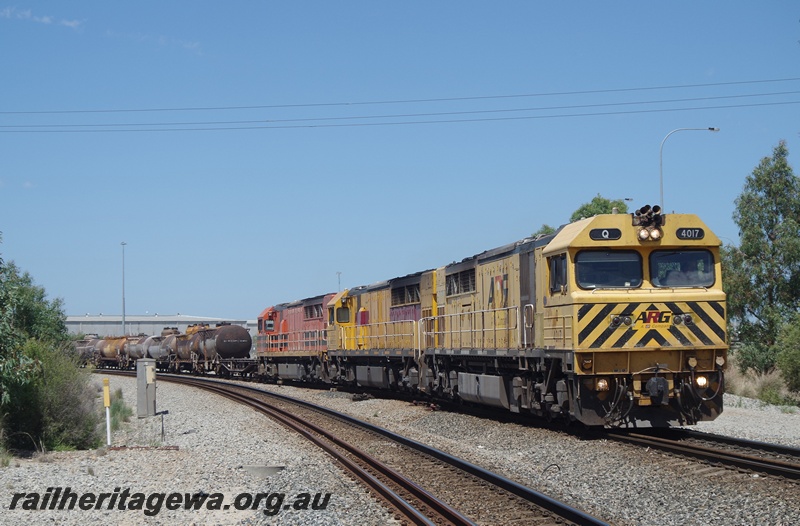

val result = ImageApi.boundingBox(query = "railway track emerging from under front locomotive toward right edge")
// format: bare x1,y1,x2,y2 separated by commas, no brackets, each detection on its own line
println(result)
604,429,800,482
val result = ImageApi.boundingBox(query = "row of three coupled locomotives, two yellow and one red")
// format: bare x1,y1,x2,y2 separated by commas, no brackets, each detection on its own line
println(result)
256,206,728,427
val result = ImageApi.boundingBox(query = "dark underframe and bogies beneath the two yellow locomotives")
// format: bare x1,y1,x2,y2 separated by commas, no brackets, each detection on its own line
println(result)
321,349,724,427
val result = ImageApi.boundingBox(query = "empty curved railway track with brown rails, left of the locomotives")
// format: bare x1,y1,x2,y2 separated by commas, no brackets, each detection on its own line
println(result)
105,371,605,525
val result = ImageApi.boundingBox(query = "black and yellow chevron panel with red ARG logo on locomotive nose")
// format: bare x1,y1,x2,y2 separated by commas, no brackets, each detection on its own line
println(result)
578,301,726,349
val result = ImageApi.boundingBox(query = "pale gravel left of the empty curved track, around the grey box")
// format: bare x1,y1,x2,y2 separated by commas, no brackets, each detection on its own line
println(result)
0,375,393,525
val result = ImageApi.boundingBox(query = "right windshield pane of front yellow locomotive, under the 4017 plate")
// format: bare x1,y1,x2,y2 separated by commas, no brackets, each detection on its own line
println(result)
650,250,714,287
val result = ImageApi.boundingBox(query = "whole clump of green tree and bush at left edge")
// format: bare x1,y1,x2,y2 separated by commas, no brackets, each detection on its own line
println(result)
0,237,100,449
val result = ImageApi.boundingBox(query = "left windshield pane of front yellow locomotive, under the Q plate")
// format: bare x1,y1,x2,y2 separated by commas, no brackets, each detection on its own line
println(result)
575,250,642,289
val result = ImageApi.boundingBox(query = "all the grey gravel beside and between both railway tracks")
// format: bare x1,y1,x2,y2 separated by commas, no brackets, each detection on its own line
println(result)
0,375,800,526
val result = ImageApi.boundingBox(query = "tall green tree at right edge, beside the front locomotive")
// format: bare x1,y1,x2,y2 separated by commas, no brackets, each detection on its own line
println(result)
722,141,800,373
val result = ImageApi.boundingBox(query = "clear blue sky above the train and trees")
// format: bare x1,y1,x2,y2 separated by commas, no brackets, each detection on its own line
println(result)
0,0,800,319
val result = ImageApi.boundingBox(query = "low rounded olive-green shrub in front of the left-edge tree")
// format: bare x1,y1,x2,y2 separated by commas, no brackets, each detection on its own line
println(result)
4,340,101,450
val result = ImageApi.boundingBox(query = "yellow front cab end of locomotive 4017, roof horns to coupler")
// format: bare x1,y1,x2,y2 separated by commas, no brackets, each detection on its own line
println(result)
540,207,727,427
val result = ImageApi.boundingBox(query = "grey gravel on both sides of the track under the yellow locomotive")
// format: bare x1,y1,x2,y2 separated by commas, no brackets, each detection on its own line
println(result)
239,386,800,526
